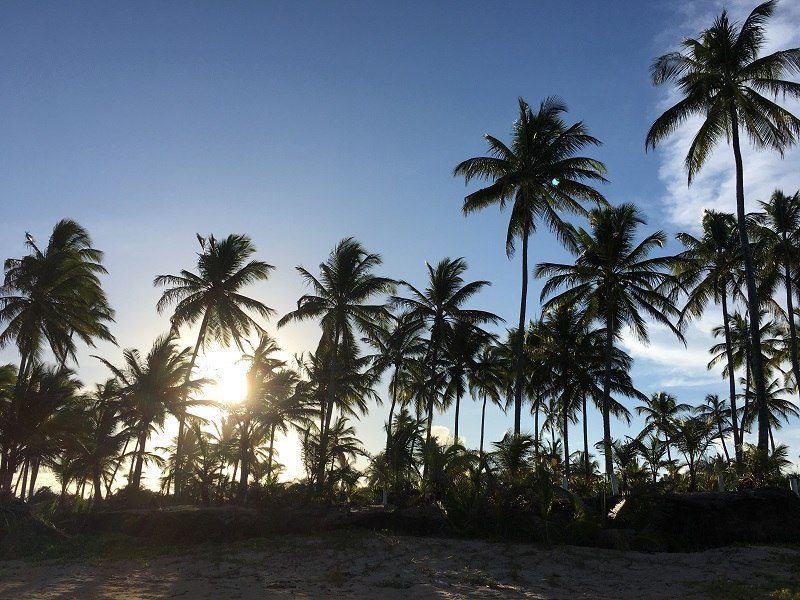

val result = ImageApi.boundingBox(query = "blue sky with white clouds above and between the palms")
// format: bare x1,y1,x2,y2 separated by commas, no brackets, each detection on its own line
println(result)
0,0,800,482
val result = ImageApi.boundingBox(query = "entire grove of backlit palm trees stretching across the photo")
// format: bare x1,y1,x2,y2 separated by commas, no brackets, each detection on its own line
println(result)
0,2,800,507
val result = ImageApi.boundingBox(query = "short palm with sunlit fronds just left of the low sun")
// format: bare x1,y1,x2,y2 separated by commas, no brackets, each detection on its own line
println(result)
96,335,210,492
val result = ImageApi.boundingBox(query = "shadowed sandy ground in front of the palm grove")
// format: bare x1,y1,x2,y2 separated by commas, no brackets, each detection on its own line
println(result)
0,532,800,600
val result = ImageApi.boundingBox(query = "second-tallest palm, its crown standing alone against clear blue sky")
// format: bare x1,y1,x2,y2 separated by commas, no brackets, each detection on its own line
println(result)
453,97,606,434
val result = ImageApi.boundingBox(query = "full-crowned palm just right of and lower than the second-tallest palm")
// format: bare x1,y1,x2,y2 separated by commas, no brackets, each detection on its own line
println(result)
535,204,683,493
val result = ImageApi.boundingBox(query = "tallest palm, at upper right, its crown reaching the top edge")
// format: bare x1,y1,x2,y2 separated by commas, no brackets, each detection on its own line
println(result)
645,0,800,449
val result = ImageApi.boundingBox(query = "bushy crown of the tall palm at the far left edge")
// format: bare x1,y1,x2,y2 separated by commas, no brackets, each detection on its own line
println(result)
0,219,114,383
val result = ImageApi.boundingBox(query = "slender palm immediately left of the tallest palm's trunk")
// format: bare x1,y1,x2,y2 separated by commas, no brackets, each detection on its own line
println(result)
675,210,742,462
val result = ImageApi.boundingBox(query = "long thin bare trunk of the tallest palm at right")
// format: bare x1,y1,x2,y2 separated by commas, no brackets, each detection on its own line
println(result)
731,118,769,450
